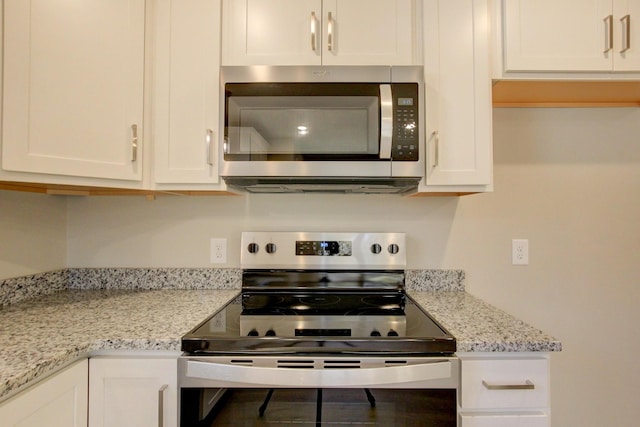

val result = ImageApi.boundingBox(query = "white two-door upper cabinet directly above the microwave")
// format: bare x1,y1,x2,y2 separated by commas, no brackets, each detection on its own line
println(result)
222,0,418,65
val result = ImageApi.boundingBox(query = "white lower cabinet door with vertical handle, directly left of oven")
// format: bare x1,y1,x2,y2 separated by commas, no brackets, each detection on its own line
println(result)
89,358,178,427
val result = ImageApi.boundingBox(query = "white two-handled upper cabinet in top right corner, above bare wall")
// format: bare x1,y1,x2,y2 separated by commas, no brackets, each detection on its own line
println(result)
502,0,640,72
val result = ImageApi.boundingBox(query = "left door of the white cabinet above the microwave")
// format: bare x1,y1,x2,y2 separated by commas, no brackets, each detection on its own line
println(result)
222,0,322,65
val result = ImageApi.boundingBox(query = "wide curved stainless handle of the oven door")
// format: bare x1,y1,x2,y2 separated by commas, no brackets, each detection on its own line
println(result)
186,360,453,388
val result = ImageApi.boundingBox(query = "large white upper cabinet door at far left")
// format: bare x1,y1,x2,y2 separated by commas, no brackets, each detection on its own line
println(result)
2,0,145,180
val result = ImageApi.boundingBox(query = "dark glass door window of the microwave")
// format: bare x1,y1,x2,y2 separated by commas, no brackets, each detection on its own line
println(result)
224,84,380,161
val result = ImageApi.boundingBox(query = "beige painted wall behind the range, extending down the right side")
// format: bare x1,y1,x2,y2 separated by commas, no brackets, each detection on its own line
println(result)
0,109,640,427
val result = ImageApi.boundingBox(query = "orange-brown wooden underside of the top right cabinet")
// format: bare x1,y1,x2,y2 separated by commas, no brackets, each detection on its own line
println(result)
493,80,640,108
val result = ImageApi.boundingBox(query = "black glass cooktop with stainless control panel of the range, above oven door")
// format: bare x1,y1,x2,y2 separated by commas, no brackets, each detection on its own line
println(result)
182,232,456,355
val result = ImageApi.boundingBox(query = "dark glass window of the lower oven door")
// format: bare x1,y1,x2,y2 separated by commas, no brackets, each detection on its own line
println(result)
181,388,456,427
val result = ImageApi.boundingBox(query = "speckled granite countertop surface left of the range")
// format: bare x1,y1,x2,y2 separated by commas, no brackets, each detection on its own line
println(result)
0,290,238,399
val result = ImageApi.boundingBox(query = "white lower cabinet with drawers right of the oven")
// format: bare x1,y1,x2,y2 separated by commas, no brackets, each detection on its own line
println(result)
458,353,550,427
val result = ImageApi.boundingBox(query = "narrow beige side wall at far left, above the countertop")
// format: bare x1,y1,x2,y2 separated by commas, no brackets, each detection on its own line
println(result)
0,191,67,279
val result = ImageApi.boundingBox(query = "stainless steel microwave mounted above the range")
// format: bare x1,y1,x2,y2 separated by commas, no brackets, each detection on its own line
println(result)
221,66,424,194
